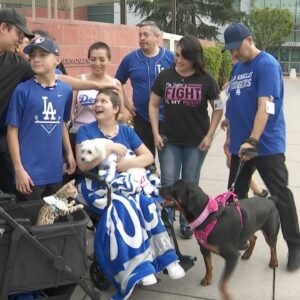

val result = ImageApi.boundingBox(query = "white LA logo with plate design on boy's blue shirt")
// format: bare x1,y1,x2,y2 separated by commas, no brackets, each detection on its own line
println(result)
34,96,61,134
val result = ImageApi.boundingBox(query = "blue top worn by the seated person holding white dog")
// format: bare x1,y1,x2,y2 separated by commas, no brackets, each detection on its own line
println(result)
76,121,142,151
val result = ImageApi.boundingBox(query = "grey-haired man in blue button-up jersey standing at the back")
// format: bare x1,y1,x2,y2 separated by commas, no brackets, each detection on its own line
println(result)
115,21,174,156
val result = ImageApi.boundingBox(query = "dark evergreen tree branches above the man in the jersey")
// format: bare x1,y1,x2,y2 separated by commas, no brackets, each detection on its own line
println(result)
128,0,244,40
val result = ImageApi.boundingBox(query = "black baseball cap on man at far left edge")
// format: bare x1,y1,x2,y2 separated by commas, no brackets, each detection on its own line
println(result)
0,8,34,39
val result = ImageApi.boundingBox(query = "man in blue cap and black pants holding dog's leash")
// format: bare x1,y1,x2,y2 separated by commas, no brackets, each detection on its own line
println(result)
223,23,300,271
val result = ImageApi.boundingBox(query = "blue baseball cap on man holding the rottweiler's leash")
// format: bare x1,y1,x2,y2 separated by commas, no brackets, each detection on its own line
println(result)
222,23,251,51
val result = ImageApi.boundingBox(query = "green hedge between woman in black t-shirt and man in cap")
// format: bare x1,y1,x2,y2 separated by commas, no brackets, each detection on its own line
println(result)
203,46,232,88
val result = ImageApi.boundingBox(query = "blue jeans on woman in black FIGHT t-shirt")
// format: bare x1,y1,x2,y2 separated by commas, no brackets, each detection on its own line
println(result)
158,143,207,229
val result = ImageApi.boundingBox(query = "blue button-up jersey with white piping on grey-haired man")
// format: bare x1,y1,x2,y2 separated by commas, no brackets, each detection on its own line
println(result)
115,48,174,121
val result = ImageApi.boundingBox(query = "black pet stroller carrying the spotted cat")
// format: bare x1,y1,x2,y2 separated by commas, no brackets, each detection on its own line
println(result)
0,193,100,300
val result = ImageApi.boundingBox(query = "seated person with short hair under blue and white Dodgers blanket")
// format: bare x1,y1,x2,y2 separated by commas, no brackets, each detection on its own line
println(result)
76,89,185,299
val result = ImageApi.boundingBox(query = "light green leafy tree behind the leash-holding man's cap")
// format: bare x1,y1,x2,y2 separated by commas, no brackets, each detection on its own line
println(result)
249,8,294,51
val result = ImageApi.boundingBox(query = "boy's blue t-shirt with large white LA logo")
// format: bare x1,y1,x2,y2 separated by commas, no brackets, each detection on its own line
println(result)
6,78,72,185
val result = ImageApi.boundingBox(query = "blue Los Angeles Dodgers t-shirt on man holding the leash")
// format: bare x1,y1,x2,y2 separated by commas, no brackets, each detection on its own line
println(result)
228,51,285,156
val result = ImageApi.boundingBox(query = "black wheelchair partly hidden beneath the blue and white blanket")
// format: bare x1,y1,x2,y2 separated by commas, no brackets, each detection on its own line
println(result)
77,170,197,290
